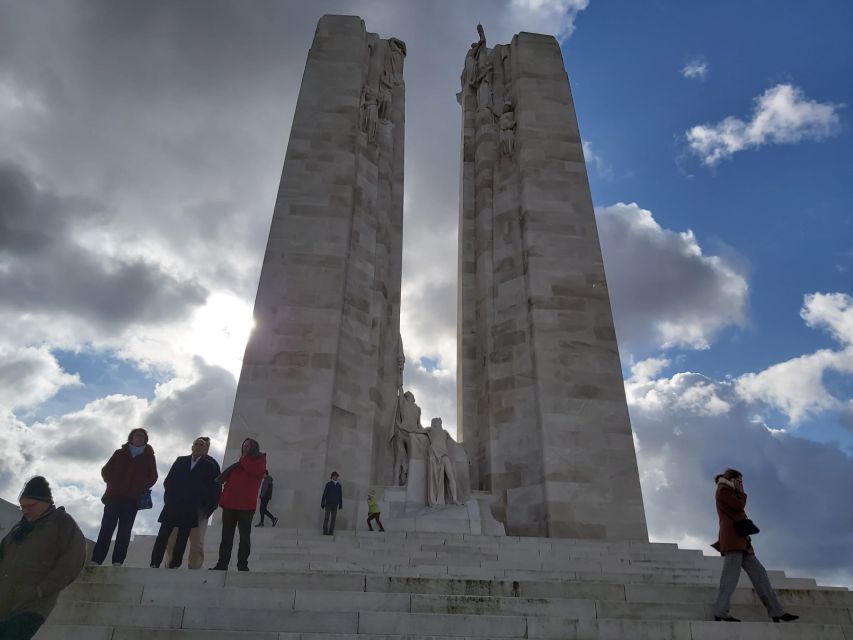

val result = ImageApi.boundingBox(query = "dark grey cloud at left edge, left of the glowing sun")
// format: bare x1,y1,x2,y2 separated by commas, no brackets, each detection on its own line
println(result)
0,163,207,331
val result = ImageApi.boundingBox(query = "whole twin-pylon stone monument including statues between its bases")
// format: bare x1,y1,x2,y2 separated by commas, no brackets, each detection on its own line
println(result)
225,16,648,540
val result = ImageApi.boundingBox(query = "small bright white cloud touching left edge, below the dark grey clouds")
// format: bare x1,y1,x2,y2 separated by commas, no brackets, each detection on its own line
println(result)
0,345,81,411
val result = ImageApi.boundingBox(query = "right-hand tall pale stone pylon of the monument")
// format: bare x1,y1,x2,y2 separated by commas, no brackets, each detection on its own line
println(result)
457,26,648,540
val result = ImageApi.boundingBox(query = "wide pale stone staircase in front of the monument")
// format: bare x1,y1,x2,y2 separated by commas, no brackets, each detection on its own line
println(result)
36,527,853,640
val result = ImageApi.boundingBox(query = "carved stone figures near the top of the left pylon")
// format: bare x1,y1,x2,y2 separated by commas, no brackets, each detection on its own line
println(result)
359,38,406,142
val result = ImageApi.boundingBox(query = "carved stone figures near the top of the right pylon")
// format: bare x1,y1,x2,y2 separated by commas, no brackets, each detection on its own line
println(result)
462,24,516,156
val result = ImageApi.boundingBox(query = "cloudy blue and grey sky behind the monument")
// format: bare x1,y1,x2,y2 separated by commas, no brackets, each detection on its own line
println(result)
0,0,853,585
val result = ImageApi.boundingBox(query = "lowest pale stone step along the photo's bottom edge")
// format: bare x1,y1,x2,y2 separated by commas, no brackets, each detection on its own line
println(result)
45,602,844,640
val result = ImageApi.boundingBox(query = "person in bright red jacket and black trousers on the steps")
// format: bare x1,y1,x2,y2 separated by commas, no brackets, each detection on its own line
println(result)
211,438,267,571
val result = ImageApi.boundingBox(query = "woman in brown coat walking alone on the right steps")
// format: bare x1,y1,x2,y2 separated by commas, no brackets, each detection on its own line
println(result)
711,469,799,622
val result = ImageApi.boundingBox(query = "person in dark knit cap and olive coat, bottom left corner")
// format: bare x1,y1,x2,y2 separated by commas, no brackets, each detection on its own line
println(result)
0,476,86,640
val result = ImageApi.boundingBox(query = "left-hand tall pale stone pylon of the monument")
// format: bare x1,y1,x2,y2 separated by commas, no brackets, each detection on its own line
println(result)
224,15,406,527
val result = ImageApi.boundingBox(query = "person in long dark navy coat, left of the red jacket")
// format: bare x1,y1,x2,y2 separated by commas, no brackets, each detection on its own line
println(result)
151,438,218,569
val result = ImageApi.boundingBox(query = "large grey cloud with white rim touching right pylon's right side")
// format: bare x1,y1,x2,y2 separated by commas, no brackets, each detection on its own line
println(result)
596,202,749,352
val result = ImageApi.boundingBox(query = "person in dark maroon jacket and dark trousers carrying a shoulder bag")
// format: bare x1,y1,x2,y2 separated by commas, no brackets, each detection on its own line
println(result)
92,429,157,567
